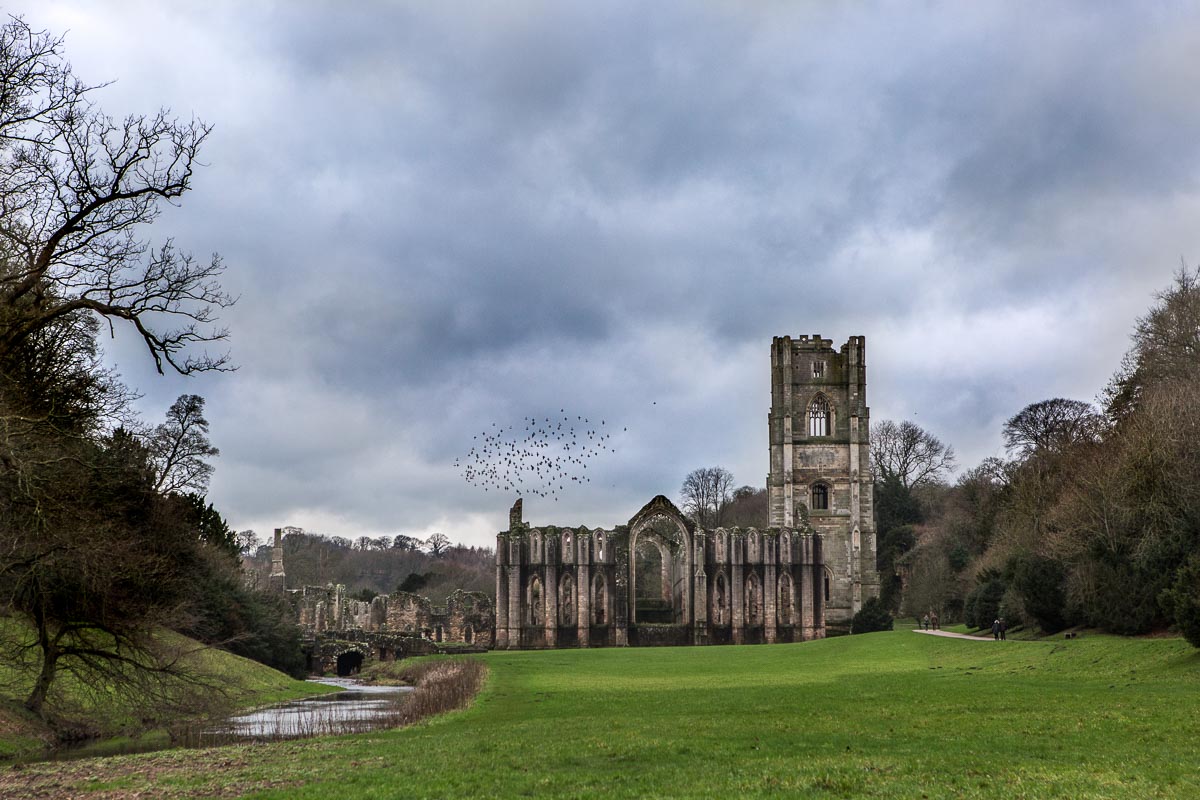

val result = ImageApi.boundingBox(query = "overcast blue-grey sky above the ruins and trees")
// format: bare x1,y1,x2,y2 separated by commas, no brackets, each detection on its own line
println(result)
11,0,1200,545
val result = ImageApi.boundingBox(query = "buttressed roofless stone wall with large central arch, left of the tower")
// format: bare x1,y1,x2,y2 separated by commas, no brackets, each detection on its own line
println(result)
496,495,824,649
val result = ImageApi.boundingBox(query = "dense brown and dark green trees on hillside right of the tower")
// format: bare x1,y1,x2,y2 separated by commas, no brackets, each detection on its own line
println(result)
872,267,1200,646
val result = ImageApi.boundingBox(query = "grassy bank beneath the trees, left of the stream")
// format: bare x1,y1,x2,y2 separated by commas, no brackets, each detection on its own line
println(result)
0,620,332,759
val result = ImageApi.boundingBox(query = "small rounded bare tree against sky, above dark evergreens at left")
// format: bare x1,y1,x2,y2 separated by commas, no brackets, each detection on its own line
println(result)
148,395,221,494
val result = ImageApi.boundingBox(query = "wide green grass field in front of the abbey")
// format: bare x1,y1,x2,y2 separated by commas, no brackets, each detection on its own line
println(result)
0,630,1200,800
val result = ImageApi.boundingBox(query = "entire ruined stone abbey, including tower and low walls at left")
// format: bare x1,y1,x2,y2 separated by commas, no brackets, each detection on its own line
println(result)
270,336,878,672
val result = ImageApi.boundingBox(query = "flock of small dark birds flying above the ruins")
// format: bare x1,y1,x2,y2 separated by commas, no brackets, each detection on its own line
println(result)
454,409,617,503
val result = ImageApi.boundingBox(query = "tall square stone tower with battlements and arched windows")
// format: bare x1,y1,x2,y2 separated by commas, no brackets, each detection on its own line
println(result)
767,336,880,626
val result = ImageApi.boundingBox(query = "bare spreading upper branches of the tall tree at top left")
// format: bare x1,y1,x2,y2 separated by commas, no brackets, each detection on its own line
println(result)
0,18,234,374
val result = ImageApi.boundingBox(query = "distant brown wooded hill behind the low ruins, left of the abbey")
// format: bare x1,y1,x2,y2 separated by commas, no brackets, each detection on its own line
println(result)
246,528,496,603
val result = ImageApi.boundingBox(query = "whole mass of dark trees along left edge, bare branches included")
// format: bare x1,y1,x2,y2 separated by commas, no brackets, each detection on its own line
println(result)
0,18,300,723
